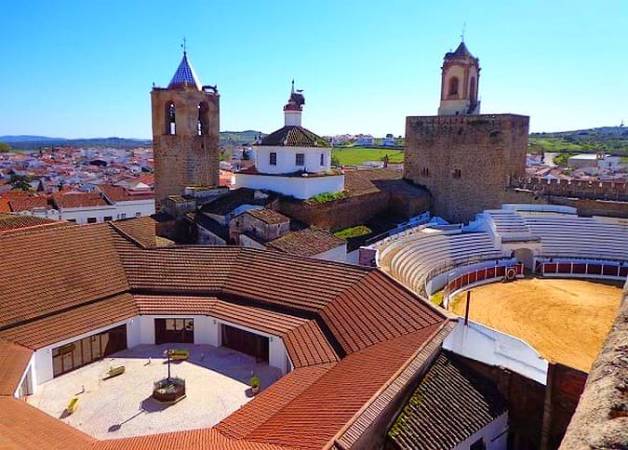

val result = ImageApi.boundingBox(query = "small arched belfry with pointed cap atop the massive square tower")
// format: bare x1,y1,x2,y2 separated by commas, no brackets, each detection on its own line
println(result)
438,41,480,116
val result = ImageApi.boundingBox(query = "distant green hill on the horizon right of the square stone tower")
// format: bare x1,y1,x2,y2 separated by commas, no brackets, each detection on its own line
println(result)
529,126,628,156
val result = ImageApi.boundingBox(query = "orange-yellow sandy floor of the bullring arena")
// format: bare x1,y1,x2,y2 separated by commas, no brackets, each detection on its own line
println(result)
450,278,622,372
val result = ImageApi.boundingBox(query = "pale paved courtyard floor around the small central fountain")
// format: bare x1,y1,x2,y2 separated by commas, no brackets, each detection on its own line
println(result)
28,344,281,439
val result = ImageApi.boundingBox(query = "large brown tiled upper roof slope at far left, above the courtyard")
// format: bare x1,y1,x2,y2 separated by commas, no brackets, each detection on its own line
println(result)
0,224,128,329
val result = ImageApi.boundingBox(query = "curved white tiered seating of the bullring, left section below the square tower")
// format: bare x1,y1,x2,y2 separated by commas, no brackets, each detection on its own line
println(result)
379,229,502,292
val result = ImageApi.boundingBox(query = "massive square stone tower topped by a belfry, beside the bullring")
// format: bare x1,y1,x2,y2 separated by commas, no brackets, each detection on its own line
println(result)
404,43,529,222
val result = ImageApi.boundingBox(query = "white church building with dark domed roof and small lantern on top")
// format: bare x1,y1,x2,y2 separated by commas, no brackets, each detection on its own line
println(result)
234,82,345,200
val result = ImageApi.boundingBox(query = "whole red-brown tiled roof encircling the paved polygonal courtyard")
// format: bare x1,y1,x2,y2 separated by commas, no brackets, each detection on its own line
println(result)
0,224,446,450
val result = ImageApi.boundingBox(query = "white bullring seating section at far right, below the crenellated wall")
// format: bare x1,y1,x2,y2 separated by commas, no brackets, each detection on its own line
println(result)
519,212,628,261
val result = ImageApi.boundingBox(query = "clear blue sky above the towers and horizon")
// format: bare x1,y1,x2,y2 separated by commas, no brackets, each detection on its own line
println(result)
0,0,628,138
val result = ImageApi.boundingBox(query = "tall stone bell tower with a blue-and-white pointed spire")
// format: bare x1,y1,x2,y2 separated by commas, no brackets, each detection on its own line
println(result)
151,51,220,209
